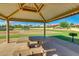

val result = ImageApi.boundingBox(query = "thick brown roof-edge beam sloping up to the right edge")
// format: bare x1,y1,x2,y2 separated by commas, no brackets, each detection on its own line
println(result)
47,7,79,22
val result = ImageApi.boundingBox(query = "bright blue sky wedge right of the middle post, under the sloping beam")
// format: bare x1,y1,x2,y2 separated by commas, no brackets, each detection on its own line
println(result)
49,14,79,24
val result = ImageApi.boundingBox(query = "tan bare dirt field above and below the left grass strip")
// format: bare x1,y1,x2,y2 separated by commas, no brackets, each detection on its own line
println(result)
0,29,60,43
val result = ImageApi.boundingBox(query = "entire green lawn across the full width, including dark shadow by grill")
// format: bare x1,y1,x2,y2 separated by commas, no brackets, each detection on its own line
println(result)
0,30,79,44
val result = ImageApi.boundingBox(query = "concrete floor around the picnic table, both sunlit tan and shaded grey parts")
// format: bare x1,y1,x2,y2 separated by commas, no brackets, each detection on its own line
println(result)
0,37,79,56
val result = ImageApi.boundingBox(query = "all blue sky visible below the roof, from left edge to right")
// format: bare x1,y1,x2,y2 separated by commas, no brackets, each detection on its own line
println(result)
0,14,79,26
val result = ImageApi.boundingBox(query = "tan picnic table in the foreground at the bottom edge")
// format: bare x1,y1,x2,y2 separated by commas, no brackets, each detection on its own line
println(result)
14,45,44,56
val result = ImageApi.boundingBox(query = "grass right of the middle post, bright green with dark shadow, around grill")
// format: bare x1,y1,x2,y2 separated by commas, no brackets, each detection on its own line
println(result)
50,30,79,44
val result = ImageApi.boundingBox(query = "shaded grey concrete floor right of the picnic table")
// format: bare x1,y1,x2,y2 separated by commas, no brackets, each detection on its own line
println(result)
43,38,79,56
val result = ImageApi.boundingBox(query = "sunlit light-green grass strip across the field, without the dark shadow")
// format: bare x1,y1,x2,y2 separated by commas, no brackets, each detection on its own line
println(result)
0,30,79,39
